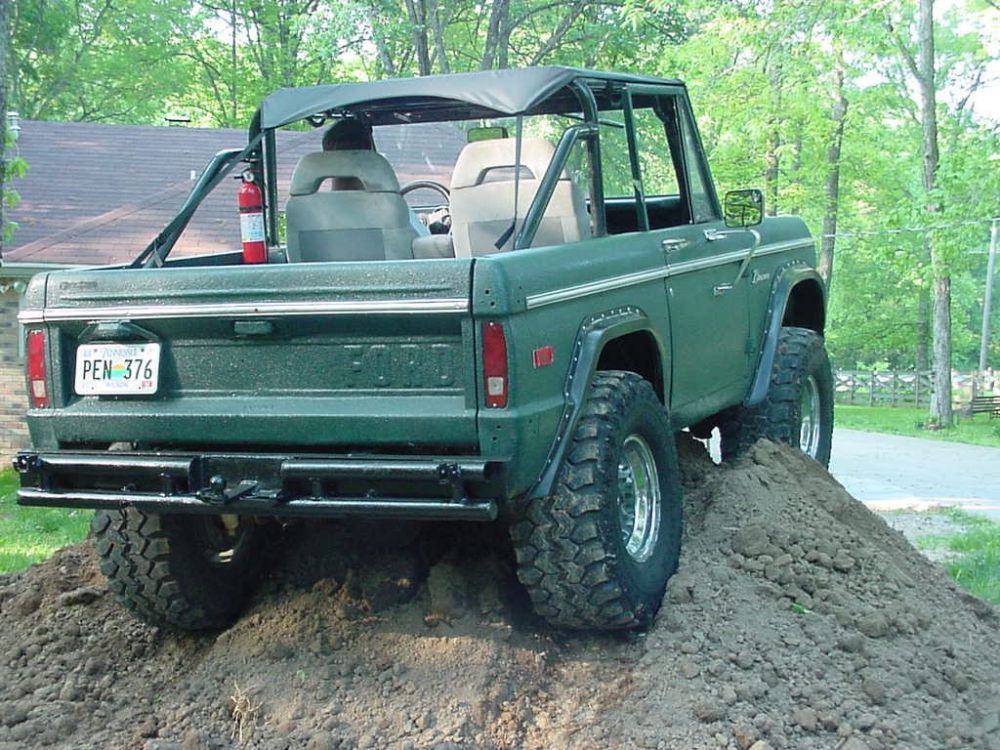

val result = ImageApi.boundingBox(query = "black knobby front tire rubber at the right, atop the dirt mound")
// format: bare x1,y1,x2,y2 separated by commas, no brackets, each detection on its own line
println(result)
719,326,833,466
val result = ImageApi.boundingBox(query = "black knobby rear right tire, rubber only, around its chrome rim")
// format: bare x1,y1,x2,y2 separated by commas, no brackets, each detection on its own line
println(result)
510,371,681,630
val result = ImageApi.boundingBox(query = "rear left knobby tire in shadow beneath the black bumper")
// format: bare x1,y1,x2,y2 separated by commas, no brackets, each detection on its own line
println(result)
92,508,263,630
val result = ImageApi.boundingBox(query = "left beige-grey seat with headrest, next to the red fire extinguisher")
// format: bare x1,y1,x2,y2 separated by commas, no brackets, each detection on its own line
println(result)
285,150,417,263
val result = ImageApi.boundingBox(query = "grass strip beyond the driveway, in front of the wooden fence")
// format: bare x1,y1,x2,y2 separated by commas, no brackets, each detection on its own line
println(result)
835,404,1000,448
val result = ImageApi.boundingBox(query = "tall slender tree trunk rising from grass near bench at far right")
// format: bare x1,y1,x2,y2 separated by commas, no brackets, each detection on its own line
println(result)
917,0,953,427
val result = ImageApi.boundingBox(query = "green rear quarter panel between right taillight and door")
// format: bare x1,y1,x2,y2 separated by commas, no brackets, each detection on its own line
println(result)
472,234,669,494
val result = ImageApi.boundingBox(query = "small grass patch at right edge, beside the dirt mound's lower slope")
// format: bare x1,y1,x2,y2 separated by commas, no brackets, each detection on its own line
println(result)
917,508,1000,605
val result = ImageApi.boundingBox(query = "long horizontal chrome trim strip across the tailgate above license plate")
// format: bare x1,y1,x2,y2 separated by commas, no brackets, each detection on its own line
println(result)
17,297,469,323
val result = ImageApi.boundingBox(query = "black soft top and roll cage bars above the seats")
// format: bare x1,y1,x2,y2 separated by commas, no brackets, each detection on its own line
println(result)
131,67,718,267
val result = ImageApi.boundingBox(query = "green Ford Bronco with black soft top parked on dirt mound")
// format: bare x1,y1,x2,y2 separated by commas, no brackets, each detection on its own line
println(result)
15,67,833,629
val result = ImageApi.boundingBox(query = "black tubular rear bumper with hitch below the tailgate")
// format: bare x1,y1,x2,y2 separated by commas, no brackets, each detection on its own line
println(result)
14,451,507,521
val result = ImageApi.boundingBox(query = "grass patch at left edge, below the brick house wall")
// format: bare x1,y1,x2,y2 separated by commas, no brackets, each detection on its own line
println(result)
0,470,91,574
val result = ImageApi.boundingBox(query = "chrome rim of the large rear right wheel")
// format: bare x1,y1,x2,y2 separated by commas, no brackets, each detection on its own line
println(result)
618,434,661,562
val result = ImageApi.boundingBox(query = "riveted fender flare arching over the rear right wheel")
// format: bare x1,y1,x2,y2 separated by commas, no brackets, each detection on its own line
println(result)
527,307,667,498
